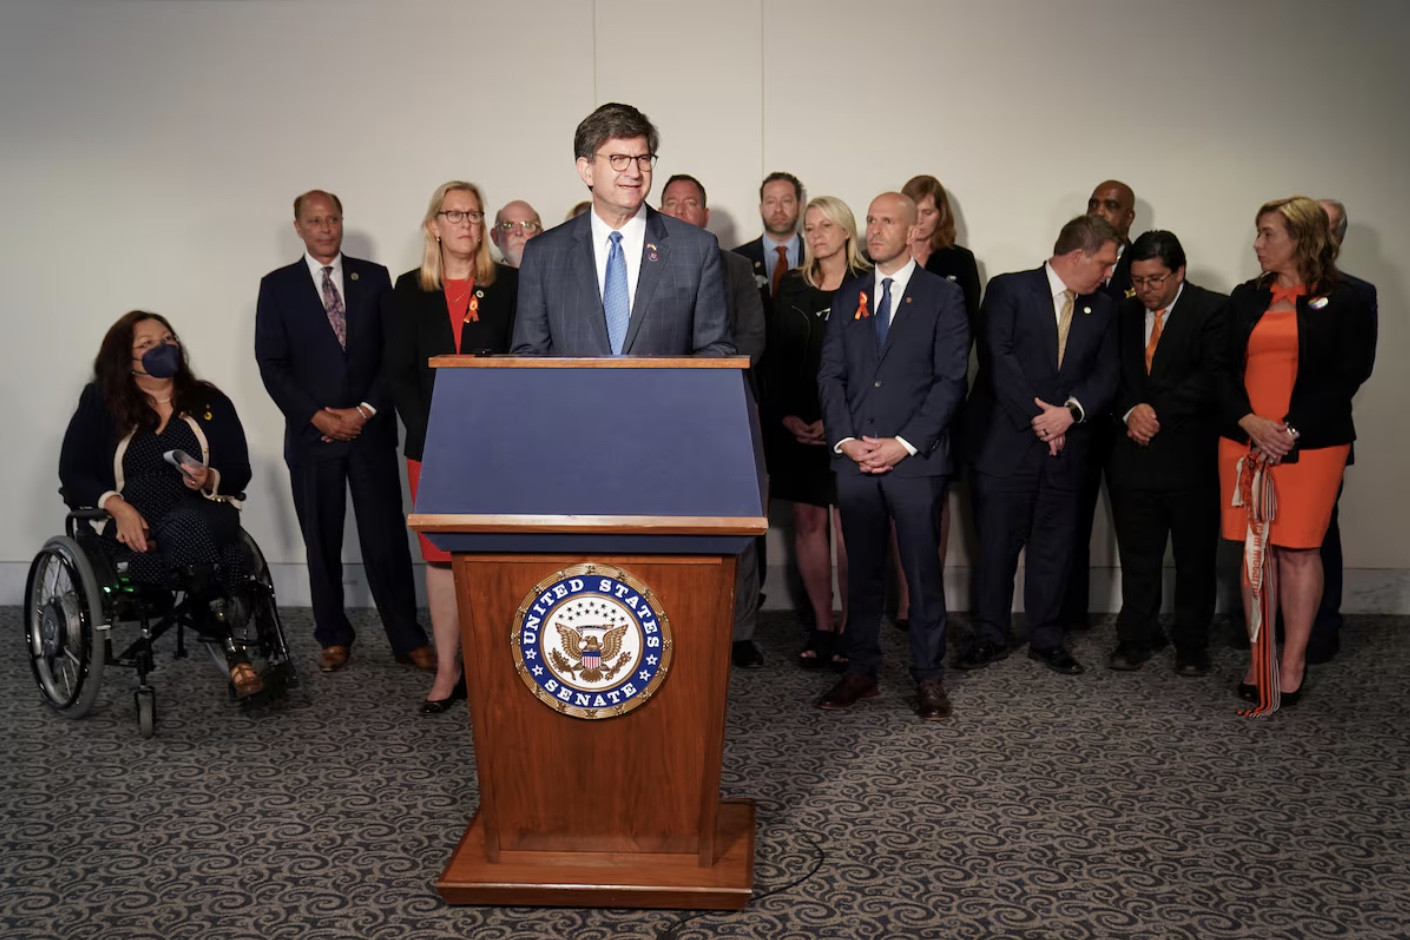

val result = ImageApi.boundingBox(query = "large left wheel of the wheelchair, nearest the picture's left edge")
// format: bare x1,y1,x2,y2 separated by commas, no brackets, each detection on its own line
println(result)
24,536,107,719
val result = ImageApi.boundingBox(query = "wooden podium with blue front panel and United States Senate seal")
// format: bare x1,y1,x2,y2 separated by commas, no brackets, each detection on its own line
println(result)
409,357,767,910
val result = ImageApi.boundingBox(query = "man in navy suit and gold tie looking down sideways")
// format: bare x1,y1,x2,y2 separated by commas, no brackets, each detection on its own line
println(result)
955,216,1118,675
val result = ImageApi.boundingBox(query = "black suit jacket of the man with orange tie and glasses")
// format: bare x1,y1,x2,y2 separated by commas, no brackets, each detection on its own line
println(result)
1108,282,1228,489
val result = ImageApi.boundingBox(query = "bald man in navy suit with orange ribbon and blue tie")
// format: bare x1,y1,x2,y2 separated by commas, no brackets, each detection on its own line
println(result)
818,193,969,722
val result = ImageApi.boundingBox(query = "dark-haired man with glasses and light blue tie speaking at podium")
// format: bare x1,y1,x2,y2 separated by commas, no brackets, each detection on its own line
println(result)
512,104,735,357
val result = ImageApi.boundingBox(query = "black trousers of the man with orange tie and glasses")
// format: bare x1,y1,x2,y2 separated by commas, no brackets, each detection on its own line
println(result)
1111,481,1220,653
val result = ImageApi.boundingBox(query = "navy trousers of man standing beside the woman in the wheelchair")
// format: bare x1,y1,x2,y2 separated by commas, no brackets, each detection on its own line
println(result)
289,447,426,653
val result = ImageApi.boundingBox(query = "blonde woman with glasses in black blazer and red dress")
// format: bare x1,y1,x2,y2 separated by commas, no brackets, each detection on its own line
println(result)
382,180,517,715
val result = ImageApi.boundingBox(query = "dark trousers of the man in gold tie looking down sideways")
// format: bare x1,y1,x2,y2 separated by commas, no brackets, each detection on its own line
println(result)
970,455,1077,650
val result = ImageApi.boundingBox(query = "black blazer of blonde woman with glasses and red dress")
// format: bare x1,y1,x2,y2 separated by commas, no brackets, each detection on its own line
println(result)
382,265,519,461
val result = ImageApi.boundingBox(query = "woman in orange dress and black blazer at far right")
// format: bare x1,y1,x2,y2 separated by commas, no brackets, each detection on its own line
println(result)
1220,196,1375,715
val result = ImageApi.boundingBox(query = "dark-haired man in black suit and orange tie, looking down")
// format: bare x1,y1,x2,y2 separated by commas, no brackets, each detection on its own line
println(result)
1107,231,1228,676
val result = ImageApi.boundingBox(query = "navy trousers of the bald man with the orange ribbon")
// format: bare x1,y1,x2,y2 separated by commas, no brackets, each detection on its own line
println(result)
838,472,946,682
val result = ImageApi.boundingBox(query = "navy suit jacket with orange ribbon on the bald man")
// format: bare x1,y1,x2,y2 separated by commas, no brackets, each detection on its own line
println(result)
818,268,969,476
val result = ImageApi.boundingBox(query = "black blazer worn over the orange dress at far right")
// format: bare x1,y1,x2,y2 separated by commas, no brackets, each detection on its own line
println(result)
1220,275,1376,461
